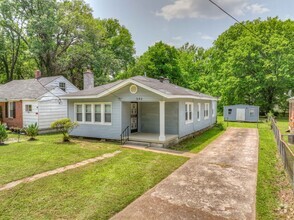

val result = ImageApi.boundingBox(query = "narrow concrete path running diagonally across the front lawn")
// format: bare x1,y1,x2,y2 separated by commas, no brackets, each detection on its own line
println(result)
0,151,121,191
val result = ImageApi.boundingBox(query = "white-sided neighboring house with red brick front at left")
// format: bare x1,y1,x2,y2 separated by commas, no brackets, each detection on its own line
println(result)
0,71,79,130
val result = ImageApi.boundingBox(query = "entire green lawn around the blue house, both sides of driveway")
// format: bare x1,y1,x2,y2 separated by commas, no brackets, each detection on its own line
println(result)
0,117,285,220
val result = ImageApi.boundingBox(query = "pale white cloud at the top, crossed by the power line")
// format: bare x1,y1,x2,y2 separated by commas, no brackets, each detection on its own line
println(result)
156,0,269,21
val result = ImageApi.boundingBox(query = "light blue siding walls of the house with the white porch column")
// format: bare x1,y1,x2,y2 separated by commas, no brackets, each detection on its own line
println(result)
68,85,216,139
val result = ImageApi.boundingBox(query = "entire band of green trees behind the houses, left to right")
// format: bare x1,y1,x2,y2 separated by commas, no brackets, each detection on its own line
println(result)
0,0,294,113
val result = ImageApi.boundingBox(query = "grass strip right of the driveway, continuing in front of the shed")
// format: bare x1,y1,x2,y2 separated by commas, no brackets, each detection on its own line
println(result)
218,117,285,220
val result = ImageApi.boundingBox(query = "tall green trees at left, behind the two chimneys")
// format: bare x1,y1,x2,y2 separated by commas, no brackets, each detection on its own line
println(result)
0,0,135,87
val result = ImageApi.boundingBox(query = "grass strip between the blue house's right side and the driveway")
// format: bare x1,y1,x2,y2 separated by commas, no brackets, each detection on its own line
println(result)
171,124,225,153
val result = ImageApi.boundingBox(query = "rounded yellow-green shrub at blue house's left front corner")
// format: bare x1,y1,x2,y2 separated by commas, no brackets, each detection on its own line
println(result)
51,118,78,142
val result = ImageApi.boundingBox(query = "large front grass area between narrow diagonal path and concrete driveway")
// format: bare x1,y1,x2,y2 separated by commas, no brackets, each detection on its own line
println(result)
0,149,187,219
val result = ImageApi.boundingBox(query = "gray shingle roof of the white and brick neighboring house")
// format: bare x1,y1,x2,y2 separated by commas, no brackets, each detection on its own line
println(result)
0,76,61,100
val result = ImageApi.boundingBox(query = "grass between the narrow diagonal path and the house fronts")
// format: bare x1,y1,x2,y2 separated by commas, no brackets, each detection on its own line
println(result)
0,134,120,185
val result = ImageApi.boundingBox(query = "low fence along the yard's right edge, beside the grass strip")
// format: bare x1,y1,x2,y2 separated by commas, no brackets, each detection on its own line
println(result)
269,117,294,189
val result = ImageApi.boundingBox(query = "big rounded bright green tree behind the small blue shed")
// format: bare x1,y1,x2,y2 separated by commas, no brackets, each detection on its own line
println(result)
210,18,294,112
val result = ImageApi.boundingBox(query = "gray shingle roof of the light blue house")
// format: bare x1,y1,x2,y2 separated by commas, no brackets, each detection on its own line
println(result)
65,76,214,99
